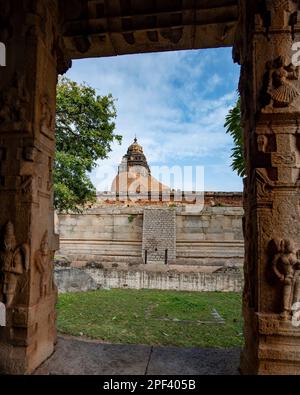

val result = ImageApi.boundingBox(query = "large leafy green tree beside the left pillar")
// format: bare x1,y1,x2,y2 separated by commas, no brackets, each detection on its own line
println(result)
54,77,122,212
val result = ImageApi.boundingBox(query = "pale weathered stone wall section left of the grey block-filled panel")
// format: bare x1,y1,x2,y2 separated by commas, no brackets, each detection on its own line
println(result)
58,207,143,266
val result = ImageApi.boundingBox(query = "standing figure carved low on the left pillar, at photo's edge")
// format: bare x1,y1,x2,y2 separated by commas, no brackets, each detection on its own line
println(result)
0,222,29,307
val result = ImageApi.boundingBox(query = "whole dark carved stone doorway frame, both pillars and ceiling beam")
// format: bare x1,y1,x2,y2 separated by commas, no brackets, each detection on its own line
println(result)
0,0,300,374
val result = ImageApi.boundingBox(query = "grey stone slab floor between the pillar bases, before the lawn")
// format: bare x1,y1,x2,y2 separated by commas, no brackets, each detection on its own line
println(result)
34,336,240,375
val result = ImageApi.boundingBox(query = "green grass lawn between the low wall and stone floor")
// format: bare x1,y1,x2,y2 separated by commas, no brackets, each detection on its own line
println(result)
57,289,243,347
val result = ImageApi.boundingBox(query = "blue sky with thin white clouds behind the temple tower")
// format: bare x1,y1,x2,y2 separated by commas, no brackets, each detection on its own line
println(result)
67,48,242,191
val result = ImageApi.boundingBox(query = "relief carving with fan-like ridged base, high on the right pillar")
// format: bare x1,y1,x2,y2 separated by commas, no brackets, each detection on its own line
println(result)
262,56,300,113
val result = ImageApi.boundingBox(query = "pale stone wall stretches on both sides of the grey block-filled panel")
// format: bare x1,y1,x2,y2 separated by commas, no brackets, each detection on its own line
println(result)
59,205,244,267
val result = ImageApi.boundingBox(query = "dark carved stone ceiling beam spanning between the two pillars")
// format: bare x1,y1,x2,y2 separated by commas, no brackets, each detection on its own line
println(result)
61,0,238,59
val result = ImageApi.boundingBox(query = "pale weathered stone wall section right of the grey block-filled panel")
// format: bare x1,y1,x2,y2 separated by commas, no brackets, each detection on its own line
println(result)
176,207,244,266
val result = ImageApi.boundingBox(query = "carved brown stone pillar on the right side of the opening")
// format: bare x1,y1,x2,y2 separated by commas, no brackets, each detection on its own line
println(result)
234,0,300,374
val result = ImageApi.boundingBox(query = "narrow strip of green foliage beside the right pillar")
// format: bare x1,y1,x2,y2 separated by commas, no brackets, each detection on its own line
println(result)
224,98,246,177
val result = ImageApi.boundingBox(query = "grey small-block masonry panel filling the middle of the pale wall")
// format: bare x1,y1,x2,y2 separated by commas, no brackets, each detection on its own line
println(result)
142,207,176,264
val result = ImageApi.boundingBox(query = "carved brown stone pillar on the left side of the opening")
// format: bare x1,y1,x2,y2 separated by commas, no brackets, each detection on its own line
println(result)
0,0,68,374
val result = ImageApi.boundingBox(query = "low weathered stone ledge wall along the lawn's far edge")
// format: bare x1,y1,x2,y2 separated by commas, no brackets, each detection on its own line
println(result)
55,268,243,293
